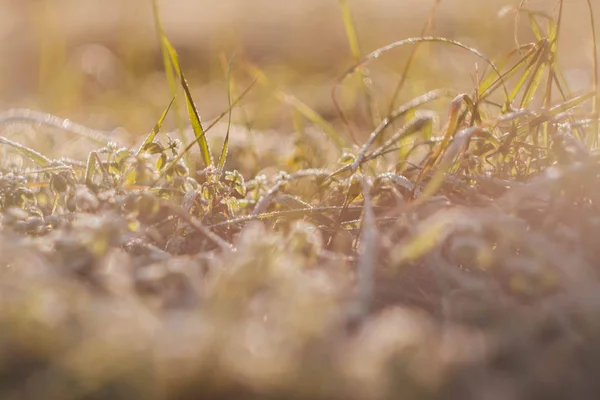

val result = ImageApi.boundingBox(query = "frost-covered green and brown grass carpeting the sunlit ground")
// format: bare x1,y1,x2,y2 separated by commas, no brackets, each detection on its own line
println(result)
0,0,600,399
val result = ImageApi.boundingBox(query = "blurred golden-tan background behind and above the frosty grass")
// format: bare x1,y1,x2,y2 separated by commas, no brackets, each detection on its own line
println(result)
0,0,600,148
